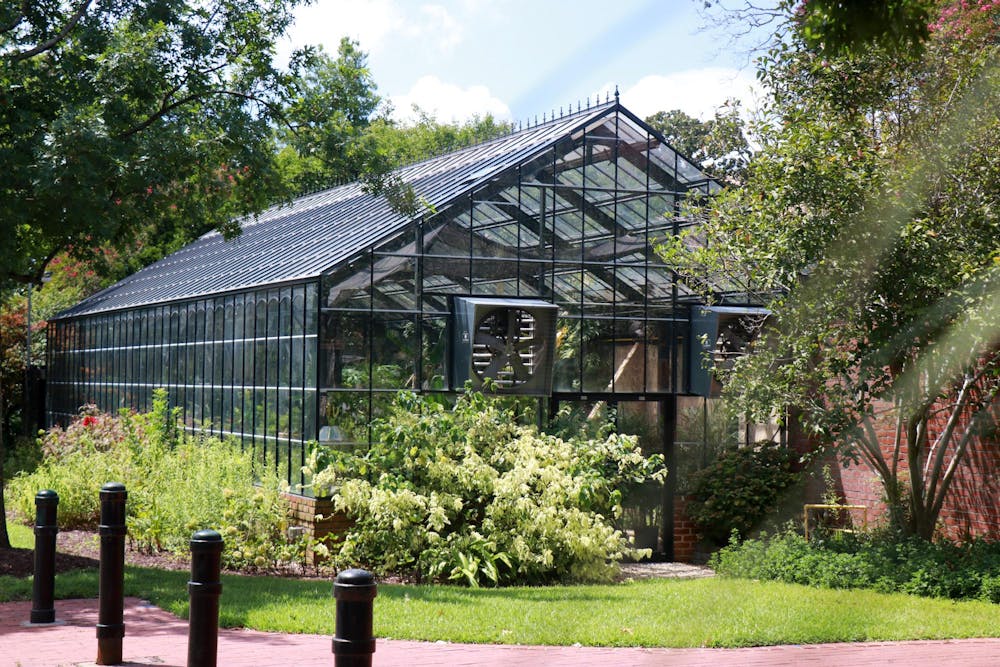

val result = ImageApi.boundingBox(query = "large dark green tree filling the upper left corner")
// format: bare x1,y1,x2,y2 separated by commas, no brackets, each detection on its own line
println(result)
0,0,312,294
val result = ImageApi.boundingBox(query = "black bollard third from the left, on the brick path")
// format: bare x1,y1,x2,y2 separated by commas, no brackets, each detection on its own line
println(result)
188,530,225,667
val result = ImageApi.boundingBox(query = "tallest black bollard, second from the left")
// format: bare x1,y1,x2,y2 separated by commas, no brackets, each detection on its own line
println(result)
97,482,127,665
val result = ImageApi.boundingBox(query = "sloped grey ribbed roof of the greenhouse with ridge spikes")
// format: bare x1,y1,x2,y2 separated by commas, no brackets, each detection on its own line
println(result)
57,102,718,318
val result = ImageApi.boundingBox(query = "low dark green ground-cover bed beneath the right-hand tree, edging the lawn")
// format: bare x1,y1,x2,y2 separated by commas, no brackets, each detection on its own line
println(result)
710,530,1000,602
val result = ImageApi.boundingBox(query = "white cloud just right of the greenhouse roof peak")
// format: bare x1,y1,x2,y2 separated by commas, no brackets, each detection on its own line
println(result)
621,67,760,120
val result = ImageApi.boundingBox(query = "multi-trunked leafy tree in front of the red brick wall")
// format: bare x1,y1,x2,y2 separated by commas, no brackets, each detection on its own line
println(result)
668,0,1000,539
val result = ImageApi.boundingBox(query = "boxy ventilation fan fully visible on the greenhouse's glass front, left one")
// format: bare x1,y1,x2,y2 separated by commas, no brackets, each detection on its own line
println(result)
451,297,559,396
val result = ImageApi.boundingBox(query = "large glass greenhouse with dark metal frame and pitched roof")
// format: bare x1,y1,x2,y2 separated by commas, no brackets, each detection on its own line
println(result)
47,99,753,556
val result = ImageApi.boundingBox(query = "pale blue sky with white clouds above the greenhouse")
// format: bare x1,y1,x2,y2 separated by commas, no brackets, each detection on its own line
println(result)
279,0,759,123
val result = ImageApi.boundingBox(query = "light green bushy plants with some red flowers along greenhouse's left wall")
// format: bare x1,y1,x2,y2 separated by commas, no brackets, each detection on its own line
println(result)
9,392,304,569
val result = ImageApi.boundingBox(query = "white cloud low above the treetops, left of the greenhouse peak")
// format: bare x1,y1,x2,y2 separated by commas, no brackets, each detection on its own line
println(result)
390,76,511,123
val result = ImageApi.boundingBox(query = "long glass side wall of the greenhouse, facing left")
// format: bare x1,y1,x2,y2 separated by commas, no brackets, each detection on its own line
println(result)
48,283,317,483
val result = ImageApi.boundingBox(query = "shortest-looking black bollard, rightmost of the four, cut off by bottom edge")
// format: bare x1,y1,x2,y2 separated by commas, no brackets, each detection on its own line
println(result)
333,570,378,667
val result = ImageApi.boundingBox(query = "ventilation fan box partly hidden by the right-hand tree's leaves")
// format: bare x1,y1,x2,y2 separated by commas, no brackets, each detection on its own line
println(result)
688,306,770,396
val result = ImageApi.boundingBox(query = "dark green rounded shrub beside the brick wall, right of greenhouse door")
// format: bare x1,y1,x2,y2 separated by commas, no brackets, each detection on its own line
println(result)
688,441,800,544
